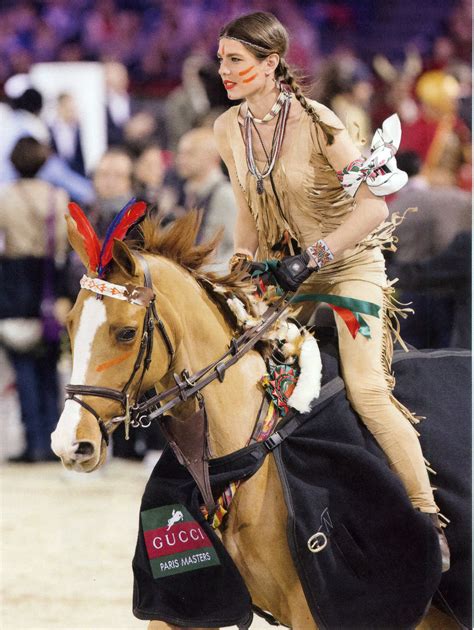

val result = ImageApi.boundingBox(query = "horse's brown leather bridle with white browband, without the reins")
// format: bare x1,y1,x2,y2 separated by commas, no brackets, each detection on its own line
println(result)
65,253,174,445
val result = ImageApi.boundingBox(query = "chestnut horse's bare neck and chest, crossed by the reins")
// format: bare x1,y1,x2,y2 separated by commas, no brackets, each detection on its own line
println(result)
156,262,265,457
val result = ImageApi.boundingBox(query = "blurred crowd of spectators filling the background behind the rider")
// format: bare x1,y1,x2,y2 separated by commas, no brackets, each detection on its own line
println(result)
0,0,472,462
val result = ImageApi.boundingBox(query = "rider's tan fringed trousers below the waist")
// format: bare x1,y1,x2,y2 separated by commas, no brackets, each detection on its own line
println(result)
300,273,438,512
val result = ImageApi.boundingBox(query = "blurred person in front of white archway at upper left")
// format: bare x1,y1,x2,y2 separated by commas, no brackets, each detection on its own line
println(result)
50,93,85,175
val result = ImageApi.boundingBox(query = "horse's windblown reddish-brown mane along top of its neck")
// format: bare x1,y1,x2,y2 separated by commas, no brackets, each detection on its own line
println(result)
129,210,255,307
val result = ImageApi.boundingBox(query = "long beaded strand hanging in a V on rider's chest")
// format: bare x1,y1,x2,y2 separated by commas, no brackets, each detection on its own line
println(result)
244,90,291,195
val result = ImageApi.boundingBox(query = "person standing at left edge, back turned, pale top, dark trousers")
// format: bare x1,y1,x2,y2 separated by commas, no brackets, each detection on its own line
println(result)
0,137,68,462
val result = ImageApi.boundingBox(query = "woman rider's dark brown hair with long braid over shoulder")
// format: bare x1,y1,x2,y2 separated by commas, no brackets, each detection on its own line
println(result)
219,11,336,144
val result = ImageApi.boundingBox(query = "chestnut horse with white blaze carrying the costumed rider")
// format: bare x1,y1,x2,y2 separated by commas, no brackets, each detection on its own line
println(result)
52,213,468,630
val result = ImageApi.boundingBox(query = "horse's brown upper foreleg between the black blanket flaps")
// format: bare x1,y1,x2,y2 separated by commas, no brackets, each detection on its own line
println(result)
223,457,316,630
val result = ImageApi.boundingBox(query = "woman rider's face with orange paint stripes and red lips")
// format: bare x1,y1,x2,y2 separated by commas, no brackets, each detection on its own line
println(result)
217,37,273,100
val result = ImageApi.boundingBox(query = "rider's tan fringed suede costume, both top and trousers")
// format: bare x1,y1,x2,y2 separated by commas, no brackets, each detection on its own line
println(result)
224,102,437,512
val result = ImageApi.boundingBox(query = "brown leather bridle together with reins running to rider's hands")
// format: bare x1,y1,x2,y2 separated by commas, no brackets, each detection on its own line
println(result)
65,252,289,445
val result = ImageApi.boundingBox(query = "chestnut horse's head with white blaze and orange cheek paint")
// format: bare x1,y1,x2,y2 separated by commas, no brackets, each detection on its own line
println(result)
51,217,174,472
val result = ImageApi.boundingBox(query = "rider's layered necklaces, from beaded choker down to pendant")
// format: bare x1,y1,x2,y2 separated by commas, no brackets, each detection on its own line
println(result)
244,89,291,195
